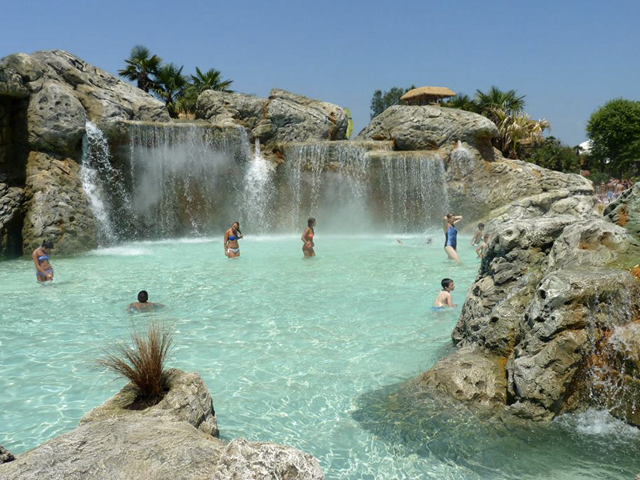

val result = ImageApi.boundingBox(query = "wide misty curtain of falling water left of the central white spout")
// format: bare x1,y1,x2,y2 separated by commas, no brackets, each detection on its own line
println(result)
129,123,251,237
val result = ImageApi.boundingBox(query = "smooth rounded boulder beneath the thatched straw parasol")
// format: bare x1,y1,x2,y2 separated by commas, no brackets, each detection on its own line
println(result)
356,105,498,151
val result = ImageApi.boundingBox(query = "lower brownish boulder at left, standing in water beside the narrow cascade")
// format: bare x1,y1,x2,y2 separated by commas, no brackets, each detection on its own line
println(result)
22,152,97,255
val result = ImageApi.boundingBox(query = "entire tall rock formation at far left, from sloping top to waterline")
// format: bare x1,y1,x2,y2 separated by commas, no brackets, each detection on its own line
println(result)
0,50,169,255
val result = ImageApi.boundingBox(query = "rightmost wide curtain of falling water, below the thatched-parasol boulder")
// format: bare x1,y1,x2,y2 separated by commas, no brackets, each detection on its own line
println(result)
382,153,449,232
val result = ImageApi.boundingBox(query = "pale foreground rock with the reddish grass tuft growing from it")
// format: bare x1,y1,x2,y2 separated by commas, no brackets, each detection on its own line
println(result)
0,370,324,480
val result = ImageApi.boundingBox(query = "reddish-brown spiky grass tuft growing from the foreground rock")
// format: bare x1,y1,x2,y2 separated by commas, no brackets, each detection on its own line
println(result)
97,322,173,406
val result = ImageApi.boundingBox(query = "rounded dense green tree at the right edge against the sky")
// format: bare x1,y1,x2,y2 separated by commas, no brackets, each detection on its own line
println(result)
587,98,640,176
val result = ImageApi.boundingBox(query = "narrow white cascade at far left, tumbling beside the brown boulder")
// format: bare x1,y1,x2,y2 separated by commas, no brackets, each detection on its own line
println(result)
80,122,117,245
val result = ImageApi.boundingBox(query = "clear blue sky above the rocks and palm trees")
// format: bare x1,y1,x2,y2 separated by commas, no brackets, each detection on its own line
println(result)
0,0,640,145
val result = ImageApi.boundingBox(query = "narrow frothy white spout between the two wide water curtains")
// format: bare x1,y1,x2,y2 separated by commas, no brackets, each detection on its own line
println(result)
242,139,274,233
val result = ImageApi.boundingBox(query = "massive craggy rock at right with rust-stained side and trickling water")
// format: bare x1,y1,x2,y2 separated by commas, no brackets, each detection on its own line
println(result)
404,182,640,426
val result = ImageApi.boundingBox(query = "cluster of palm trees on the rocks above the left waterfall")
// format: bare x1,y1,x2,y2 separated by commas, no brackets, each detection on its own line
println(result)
118,45,233,118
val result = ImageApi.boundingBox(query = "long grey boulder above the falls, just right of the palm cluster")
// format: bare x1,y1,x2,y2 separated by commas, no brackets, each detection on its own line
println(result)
196,89,348,154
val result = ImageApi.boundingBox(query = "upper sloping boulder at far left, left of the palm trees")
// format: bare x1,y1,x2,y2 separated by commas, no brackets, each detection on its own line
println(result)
0,50,169,158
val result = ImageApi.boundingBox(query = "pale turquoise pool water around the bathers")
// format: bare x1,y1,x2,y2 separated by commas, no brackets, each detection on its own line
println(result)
0,234,640,479
